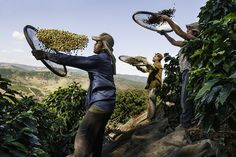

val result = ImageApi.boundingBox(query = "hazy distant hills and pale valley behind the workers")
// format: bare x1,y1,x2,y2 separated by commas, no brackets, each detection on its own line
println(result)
0,63,147,98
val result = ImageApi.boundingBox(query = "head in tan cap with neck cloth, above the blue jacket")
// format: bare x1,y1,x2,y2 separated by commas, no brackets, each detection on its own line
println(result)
92,33,114,54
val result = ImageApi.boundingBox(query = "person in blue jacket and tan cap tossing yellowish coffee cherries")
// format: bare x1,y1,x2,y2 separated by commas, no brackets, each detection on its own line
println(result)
32,33,116,157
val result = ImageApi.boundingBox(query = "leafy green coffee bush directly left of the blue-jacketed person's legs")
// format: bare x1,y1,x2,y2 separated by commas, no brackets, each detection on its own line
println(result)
41,82,86,157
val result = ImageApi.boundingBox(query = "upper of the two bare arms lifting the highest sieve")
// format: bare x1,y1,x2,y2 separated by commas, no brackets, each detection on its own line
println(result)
161,15,196,40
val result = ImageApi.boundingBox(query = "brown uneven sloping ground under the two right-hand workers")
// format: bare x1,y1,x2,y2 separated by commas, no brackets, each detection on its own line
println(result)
103,110,236,157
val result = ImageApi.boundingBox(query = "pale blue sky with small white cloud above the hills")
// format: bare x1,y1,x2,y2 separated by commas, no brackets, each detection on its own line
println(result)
0,0,207,76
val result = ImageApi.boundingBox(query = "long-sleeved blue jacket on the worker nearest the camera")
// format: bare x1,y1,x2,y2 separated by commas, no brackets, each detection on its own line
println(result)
47,51,116,112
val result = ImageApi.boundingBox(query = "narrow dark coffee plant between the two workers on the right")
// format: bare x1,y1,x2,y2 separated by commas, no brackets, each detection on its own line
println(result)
159,53,181,128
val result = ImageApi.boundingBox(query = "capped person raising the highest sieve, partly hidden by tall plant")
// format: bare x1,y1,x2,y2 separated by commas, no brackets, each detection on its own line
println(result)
161,15,200,129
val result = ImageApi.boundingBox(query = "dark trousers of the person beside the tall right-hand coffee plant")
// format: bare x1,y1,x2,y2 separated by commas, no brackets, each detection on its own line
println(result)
180,70,194,128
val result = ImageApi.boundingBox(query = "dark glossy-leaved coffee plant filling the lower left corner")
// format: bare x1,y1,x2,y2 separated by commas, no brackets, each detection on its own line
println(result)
0,75,48,157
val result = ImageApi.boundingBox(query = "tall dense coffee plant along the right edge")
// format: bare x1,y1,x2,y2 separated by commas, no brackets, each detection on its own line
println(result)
183,0,236,131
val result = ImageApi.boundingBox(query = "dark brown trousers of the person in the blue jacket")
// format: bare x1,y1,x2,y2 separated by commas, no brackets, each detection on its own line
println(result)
74,111,111,157
